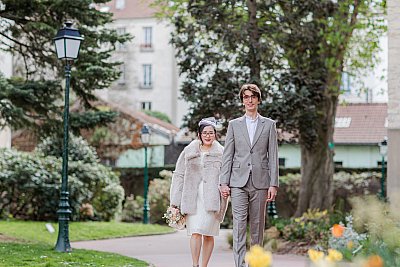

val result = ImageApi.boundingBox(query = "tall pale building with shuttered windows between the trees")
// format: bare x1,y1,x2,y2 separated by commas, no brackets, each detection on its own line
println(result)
98,0,188,127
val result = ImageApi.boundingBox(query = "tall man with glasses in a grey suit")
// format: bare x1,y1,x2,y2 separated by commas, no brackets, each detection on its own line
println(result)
219,84,279,267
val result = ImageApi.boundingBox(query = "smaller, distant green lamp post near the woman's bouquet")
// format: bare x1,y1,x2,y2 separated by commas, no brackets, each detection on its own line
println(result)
140,124,151,224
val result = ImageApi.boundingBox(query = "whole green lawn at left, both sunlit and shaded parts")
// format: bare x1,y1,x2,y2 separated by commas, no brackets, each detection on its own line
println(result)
0,221,174,267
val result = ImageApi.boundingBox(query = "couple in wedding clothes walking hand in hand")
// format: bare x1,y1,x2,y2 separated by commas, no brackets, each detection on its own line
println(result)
170,84,279,267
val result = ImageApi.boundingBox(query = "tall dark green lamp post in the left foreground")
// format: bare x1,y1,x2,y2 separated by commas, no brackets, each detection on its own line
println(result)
54,22,83,252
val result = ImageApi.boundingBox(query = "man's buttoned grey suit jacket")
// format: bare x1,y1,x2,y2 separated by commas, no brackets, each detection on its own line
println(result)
220,115,279,189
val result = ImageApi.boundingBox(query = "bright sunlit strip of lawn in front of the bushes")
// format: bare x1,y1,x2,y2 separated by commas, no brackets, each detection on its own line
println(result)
0,221,174,245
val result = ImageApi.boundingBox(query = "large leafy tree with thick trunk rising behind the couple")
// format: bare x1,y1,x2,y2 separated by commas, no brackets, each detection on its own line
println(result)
156,0,386,215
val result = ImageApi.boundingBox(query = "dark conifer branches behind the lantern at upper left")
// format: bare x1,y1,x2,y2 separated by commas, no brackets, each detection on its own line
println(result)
0,0,131,134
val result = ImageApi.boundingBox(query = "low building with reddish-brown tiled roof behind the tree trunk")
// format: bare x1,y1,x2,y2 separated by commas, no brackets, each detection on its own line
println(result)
279,103,387,168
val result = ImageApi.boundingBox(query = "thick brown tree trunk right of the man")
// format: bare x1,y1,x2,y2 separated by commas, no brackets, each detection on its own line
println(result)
295,97,337,217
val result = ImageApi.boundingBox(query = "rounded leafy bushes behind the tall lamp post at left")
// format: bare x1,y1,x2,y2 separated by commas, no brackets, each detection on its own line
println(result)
0,136,124,220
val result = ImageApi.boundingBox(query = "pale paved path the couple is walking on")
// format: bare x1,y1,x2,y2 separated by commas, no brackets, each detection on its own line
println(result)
72,229,307,267
